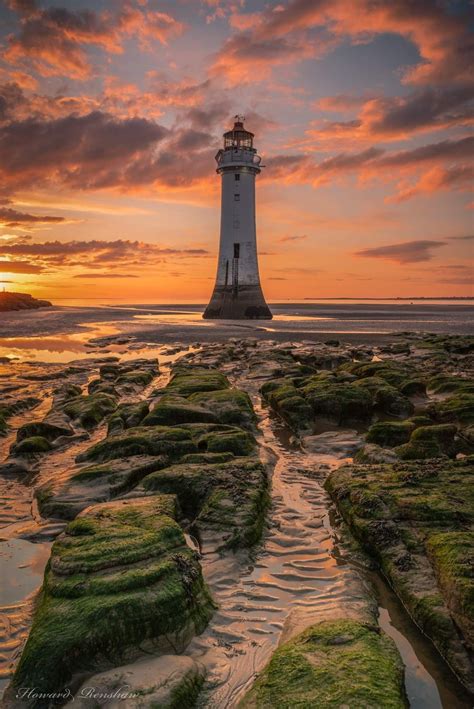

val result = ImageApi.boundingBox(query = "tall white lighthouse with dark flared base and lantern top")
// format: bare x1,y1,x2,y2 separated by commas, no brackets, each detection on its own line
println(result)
203,116,272,320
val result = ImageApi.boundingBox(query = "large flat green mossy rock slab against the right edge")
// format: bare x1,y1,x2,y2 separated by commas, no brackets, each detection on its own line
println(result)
326,454,474,690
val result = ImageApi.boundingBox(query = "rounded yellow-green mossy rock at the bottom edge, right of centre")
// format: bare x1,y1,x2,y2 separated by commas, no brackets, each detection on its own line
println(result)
239,620,408,709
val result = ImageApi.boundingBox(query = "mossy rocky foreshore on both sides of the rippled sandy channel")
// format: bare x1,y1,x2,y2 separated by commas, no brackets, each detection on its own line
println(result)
0,333,474,709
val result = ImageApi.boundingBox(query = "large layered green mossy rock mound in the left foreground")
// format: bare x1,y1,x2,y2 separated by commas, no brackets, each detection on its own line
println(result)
13,496,212,692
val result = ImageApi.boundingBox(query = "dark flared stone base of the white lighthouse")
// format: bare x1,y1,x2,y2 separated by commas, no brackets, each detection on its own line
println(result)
203,285,273,320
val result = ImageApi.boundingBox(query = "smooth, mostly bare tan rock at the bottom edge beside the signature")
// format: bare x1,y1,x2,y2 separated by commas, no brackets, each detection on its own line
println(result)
71,655,205,709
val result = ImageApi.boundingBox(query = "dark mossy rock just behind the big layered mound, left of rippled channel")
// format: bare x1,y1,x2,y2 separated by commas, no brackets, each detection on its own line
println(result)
142,458,268,548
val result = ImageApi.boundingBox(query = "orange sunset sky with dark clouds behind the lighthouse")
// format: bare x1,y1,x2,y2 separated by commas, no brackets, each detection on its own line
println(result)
0,0,474,302
